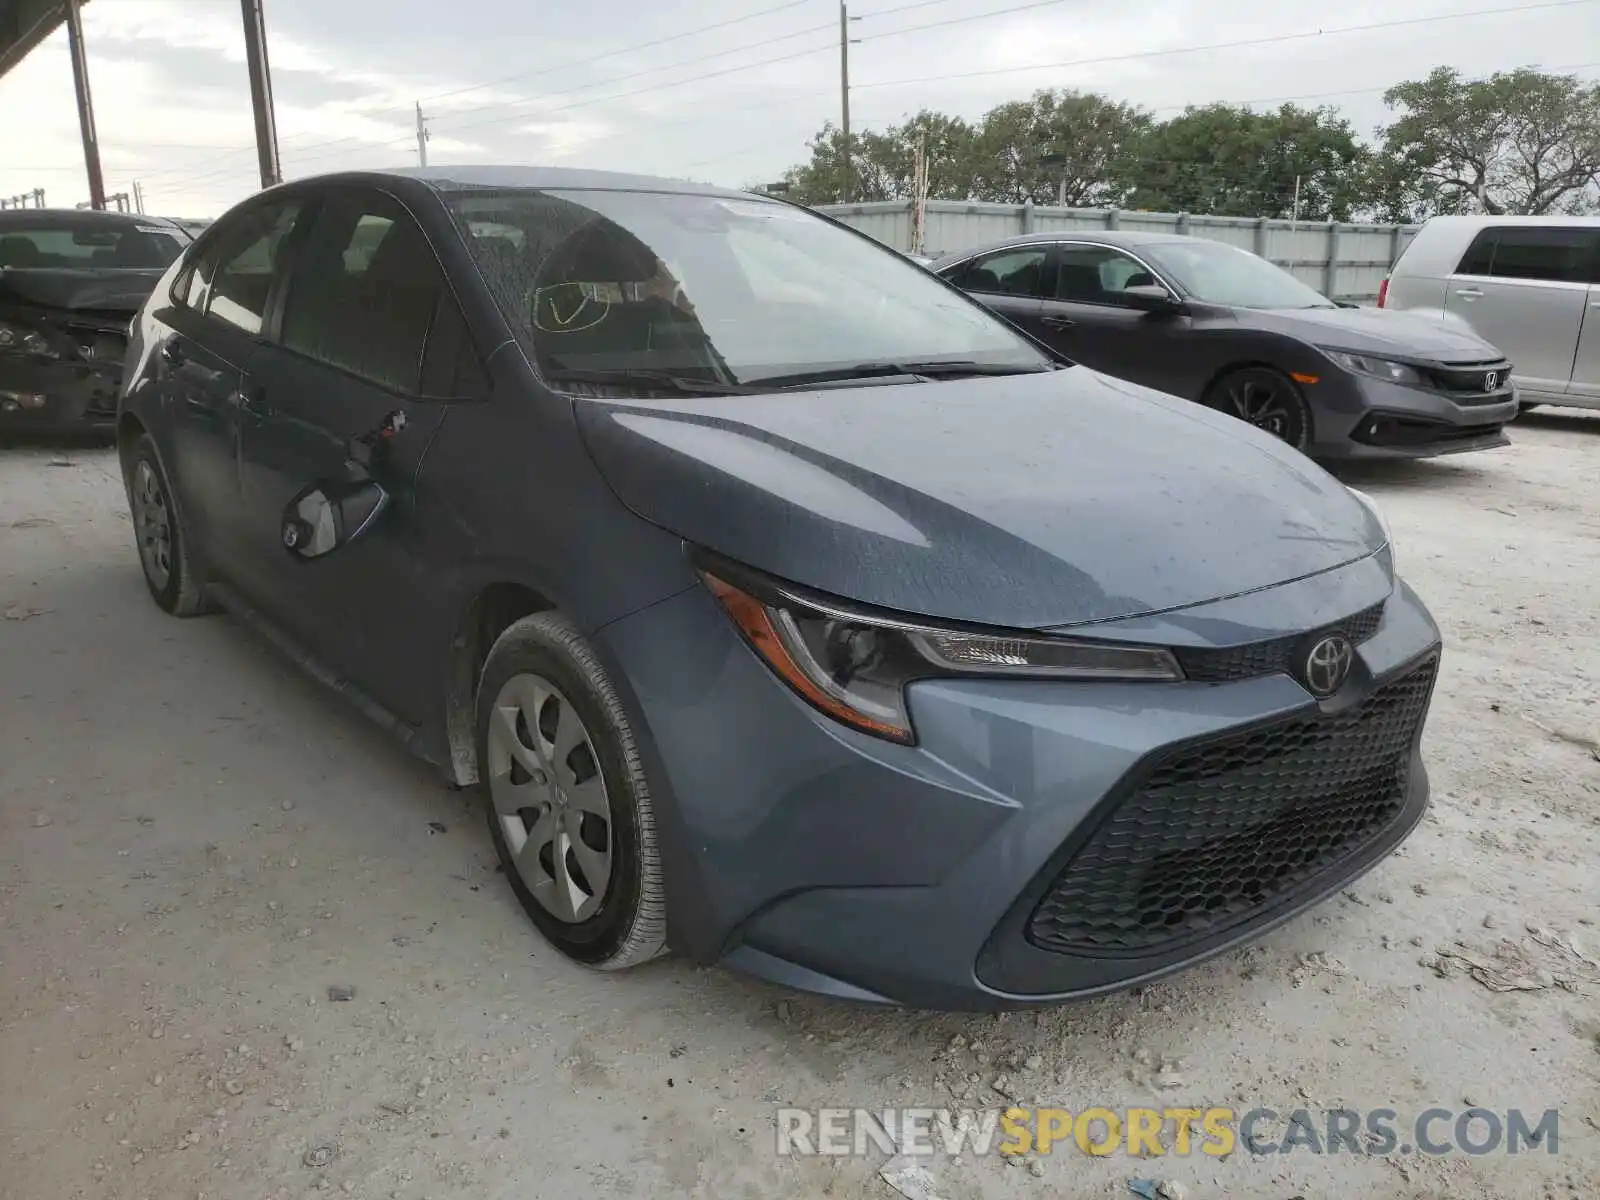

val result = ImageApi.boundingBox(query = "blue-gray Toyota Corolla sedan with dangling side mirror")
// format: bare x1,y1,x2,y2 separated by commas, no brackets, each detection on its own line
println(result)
118,168,1438,1008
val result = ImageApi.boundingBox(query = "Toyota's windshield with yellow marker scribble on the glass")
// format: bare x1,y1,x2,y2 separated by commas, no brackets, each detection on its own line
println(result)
445,189,1050,386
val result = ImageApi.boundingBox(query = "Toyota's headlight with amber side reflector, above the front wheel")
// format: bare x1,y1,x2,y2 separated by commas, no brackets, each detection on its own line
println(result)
701,560,1184,744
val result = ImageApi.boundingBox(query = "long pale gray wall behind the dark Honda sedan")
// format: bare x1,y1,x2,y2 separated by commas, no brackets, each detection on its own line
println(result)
818,200,1418,301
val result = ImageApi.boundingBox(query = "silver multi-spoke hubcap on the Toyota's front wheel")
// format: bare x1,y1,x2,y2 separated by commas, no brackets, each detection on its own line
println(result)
488,674,613,925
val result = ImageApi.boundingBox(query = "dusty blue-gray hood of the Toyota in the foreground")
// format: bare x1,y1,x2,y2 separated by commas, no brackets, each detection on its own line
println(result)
574,366,1384,627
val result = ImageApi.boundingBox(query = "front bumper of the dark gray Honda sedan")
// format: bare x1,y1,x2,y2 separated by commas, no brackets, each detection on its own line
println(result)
1310,374,1518,459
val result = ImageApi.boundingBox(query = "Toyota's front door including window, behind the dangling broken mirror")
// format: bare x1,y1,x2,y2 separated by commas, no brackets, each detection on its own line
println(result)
242,189,486,723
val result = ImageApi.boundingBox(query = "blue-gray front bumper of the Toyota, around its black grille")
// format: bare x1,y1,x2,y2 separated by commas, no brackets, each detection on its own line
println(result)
598,557,1438,1010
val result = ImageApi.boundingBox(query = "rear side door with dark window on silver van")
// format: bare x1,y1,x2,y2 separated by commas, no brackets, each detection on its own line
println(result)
1445,224,1600,395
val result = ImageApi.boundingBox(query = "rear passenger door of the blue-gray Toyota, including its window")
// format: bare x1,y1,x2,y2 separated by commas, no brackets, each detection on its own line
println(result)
155,200,301,576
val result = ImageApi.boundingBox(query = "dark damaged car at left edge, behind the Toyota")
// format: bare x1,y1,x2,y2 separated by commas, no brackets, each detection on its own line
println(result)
0,208,190,434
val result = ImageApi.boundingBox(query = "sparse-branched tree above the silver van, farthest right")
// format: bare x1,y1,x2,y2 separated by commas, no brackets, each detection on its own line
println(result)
1379,67,1600,219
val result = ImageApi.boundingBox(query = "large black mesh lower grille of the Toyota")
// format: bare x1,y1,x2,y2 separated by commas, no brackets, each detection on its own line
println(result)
1027,658,1438,955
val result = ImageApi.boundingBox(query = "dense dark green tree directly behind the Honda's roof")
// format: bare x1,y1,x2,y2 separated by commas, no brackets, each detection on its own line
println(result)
1126,104,1371,221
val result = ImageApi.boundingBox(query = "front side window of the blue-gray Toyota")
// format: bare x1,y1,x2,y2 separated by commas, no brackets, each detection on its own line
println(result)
282,192,485,398
